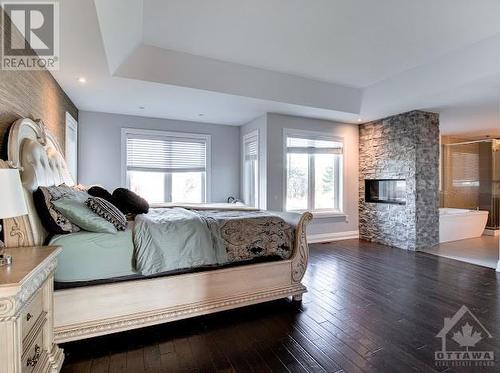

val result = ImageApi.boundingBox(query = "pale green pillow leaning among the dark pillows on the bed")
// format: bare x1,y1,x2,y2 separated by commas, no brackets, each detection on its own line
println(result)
52,196,117,233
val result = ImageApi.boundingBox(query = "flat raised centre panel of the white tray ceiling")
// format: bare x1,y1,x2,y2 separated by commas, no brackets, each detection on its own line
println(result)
143,0,500,87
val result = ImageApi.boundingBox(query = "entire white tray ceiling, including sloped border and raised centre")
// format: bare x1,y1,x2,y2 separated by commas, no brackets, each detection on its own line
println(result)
50,0,500,132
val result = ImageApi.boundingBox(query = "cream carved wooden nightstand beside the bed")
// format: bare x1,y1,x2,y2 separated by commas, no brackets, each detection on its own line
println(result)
0,246,64,373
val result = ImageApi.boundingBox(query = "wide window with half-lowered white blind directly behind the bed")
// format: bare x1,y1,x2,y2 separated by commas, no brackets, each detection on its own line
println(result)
126,129,210,203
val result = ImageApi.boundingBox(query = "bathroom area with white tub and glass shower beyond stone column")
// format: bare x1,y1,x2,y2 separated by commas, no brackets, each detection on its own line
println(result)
426,134,500,270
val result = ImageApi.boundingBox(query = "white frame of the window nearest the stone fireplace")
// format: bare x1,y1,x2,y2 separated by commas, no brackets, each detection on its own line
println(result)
282,128,347,217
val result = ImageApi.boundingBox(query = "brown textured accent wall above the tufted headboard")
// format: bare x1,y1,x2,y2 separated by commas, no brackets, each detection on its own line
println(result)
0,10,78,159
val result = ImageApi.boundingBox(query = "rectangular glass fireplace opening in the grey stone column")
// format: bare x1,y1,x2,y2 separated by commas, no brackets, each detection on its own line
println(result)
365,179,406,205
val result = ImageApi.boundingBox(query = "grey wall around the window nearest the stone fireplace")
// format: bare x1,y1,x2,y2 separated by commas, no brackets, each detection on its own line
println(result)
242,114,359,235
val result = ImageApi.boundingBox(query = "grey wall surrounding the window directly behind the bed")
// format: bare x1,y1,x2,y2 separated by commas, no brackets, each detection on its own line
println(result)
78,111,240,202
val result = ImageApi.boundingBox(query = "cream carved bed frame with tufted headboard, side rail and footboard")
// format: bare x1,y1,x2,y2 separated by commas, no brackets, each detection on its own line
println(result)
0,119,312,343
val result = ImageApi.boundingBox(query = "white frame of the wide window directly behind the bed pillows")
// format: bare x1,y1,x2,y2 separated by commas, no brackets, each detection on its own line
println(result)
121,128,212,203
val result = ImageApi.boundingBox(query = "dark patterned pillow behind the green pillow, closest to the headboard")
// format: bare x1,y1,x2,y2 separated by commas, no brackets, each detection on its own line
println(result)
33,184,87,234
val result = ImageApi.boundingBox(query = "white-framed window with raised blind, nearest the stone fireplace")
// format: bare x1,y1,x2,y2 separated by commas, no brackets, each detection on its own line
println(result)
285,131,343,212
